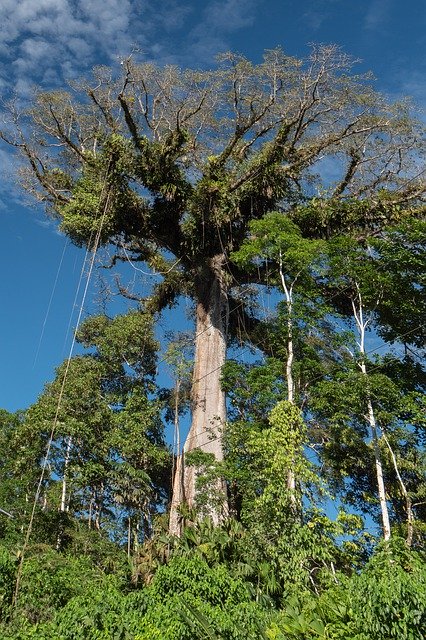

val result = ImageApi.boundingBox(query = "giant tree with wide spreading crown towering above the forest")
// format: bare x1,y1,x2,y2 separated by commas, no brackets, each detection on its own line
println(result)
2,46,422,528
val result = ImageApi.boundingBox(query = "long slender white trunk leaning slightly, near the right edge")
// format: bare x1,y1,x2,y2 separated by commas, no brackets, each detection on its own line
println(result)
352,286,391,540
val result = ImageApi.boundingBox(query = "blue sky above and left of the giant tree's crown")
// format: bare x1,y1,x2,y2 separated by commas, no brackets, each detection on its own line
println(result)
0,0,426,411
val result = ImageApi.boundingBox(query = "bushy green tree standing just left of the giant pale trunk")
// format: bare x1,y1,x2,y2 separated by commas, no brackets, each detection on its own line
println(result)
2,310,170,556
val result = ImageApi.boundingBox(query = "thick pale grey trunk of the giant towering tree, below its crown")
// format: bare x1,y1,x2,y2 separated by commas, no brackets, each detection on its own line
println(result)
170,255,228,535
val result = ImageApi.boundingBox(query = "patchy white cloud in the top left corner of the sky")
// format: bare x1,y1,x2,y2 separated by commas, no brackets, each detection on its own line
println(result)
0,0,140,95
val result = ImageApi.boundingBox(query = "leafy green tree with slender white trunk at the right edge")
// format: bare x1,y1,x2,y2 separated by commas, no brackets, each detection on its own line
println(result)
312,228,425,544
